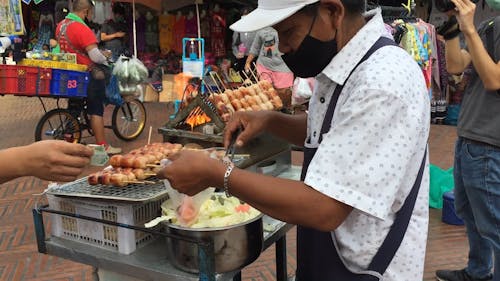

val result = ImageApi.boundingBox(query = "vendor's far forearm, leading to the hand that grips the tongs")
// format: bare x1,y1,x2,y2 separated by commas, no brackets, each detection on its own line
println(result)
266,112,307,146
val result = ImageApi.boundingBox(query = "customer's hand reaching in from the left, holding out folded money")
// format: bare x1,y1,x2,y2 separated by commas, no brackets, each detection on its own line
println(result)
19,140,94,182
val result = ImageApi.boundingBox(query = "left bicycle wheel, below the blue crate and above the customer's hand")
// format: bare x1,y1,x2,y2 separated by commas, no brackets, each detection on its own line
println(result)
35,108,82,143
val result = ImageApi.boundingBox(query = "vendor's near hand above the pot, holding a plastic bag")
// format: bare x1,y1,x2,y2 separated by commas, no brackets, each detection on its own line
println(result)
157,150,225,196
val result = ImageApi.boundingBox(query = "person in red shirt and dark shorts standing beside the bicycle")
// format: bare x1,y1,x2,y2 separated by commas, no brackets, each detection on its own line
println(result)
56,0,121,154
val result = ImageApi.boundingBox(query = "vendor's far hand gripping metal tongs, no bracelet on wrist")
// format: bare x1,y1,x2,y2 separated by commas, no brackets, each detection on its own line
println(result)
224,111,273,147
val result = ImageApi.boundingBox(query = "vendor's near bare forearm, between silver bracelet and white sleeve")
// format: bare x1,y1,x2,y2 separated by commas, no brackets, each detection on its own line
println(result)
207,161,352,231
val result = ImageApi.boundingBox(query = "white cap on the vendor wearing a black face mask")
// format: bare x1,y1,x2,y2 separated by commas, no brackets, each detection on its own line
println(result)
229,0,319,32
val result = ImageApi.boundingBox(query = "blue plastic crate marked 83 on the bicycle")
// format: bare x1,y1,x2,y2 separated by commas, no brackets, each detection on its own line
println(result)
50,69,89,97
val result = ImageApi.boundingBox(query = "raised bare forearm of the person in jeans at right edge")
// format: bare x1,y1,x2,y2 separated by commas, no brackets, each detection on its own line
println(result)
464,29,500,90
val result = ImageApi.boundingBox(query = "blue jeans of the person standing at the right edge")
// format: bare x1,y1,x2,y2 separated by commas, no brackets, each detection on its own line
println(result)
454,138,500,281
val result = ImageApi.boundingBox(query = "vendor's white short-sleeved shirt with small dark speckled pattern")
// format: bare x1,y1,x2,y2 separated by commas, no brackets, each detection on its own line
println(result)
305,9,430,281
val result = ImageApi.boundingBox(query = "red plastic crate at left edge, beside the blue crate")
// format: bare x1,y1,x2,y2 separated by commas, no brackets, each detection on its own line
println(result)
0,65,52,96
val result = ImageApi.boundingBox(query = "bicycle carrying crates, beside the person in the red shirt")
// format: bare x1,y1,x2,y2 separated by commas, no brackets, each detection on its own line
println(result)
35,97,146,143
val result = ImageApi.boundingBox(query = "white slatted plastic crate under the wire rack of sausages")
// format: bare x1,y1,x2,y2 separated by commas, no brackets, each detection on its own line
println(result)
47,194,168,255
